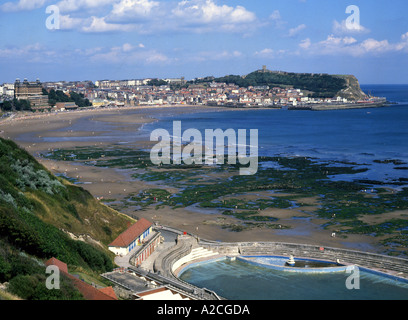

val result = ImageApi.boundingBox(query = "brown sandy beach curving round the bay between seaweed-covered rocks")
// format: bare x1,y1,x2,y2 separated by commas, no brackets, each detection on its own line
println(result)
0,106,388,252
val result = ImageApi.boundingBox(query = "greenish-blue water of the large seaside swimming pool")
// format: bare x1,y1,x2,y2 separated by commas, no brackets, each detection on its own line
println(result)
179,259,408,300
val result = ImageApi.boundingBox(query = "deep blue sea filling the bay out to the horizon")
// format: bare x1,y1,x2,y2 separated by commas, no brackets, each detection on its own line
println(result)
143,85,408,188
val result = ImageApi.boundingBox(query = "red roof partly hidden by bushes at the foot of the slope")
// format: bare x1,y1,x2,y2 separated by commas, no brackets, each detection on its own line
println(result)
45,258,118,300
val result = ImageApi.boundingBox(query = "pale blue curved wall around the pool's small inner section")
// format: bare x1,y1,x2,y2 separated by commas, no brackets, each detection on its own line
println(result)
236,256,352,273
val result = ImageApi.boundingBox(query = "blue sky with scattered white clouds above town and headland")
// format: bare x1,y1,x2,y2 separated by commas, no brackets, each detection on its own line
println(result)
0,0,408,84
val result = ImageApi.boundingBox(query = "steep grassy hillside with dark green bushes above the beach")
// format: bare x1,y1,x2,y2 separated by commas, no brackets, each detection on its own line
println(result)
0,138,130,299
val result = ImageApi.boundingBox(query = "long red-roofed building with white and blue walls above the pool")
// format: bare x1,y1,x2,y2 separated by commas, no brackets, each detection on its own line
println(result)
108,218,153,255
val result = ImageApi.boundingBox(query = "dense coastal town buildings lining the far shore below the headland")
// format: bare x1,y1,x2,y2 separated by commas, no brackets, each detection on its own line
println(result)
0,77,384,111
